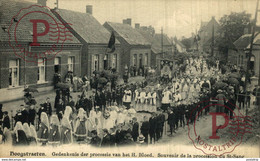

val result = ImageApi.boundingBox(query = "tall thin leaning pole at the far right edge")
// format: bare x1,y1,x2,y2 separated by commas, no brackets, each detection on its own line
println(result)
244,0,260,115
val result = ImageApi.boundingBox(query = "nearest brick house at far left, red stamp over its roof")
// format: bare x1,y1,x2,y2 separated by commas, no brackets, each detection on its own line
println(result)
0,1,81,102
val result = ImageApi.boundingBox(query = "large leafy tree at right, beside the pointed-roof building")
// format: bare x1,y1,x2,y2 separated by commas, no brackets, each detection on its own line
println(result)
216,12,251,55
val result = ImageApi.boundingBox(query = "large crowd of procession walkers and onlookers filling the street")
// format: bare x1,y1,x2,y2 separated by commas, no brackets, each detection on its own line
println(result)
0,55,256,147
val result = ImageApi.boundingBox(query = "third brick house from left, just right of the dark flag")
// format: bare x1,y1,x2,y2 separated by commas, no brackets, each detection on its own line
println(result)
103,19,151,73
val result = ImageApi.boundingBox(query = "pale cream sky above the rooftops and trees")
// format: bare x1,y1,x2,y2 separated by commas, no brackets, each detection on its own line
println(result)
23,0,260,38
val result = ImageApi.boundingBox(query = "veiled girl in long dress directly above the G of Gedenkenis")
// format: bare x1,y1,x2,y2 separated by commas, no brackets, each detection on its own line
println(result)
48,115,61,146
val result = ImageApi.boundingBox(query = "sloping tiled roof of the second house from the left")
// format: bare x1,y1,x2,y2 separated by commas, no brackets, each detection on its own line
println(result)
55,9,119,44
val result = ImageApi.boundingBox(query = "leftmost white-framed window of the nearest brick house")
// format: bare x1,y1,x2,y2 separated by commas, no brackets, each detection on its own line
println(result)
9,59,19,87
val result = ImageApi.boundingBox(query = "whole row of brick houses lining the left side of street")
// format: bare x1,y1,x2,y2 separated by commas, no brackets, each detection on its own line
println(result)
0,0,179,102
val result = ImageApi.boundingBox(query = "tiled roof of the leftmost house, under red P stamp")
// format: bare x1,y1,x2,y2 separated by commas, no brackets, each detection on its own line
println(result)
0,0,80,44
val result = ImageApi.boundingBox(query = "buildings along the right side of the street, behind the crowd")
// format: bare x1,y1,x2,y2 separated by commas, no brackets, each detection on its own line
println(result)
198,17,260,85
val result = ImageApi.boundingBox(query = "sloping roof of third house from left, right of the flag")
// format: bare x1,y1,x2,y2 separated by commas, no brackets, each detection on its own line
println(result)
104,22,151,45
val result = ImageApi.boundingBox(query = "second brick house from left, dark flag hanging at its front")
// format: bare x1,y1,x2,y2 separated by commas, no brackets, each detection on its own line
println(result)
55,6,121,76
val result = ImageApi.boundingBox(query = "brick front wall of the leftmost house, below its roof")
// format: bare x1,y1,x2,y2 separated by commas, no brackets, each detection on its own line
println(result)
0,44,81,102
